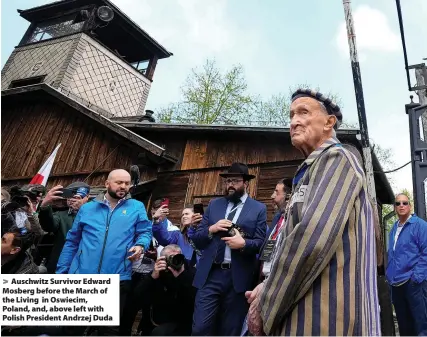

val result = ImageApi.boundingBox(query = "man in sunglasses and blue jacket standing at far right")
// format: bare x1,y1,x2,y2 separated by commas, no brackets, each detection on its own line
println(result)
386,194,427,336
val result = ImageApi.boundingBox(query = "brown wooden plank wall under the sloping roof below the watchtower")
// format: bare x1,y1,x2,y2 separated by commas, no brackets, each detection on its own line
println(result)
1,101,149,187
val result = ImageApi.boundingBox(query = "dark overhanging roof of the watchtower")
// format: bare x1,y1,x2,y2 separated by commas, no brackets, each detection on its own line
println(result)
18,0,173,63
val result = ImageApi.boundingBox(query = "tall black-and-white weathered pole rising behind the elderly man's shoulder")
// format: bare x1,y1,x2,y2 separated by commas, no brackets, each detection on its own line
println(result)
343,0,377,207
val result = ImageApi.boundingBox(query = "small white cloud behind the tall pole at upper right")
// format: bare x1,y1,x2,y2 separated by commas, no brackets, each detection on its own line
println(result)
335,5,400,60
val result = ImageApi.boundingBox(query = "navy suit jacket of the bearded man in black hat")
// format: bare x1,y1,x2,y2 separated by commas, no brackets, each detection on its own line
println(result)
191,197,267,293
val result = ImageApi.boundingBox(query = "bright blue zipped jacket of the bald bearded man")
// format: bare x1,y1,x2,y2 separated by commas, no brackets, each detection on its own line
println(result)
56,194,152,281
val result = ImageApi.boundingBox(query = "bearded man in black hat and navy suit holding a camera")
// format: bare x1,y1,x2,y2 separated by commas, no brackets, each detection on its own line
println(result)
191,163,267,336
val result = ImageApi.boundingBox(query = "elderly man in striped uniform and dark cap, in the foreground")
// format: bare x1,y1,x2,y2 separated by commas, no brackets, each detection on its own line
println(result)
246,89,381,336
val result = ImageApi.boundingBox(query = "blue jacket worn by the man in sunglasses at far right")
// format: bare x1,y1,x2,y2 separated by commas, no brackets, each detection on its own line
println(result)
386,214,427,284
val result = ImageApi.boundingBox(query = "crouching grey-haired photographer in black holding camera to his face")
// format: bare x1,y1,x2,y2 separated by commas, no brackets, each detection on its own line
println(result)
145,245,196,336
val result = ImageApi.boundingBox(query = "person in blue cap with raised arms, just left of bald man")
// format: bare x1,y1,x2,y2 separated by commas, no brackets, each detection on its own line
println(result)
39,181,90,274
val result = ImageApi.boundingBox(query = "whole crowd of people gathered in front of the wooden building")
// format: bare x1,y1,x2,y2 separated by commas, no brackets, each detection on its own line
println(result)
1,89,427,336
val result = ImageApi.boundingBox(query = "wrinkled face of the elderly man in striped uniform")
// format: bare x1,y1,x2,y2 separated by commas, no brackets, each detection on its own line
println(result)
290,97,334,150
